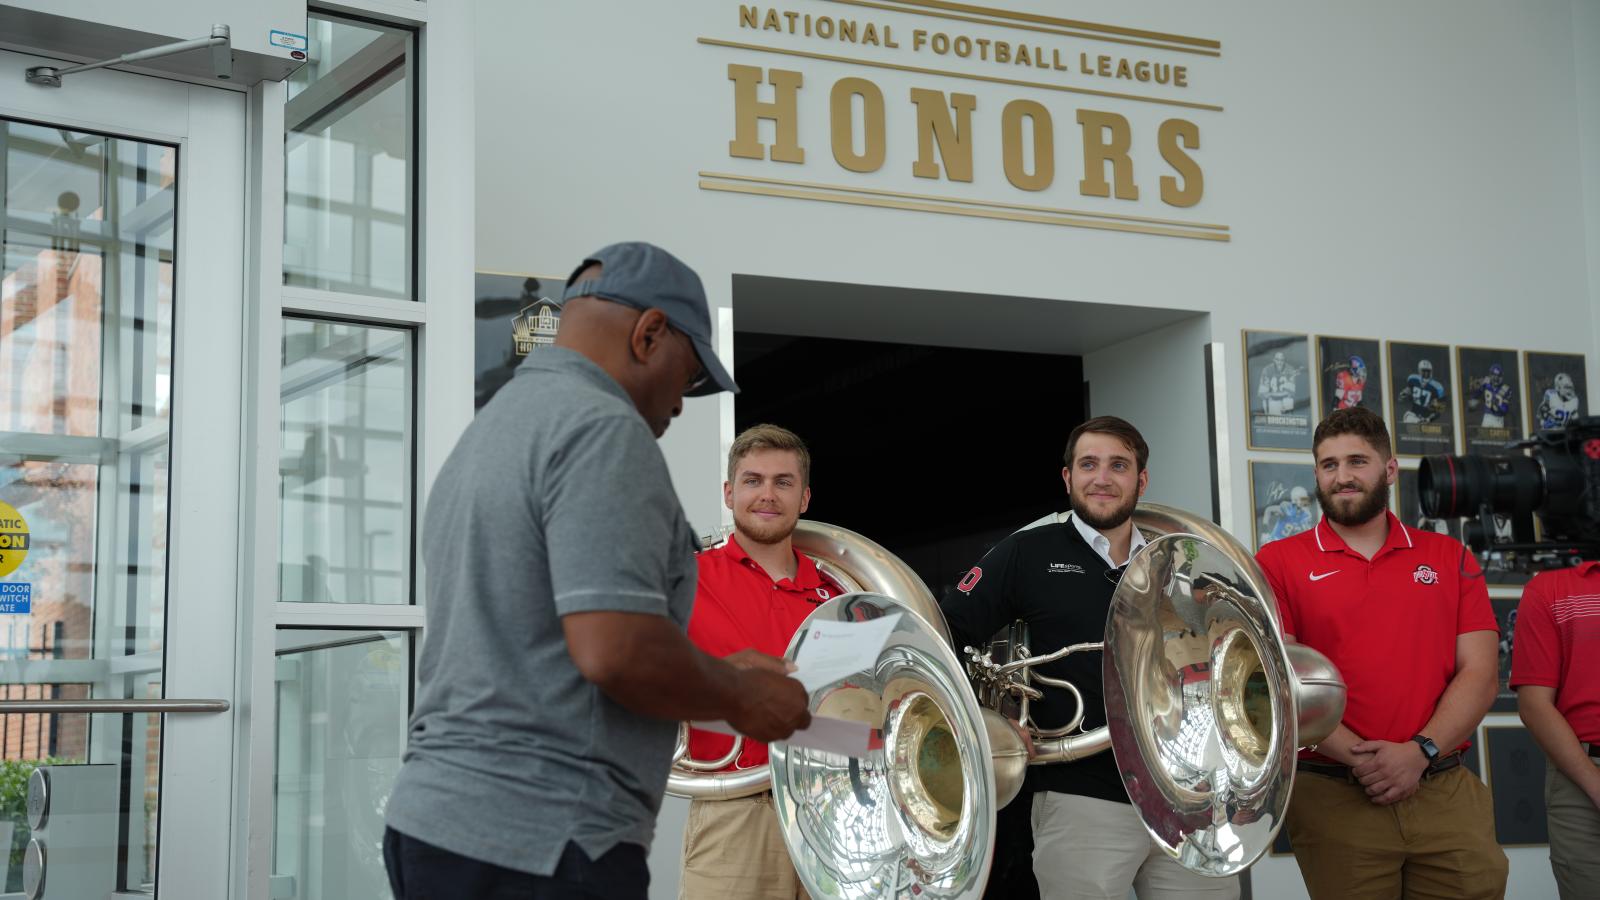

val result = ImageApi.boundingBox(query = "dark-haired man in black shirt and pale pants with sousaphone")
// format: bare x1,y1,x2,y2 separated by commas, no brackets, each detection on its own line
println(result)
941,416,1238,900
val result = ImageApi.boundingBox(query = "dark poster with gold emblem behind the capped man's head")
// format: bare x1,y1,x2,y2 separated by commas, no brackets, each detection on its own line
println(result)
472,272,566,412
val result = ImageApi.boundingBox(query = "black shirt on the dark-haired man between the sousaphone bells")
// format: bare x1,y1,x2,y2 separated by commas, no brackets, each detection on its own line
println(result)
939,520,1128,802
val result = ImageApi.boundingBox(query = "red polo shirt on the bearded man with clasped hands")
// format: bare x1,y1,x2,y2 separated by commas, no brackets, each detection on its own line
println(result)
1256,512,1498,756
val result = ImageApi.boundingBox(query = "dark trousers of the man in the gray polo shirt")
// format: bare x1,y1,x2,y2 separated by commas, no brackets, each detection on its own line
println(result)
384,828,650,900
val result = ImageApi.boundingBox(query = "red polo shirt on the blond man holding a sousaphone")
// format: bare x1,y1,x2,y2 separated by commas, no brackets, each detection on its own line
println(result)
690,535,845,769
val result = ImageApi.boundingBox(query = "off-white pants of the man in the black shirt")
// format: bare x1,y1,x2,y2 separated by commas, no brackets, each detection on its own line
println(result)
1034,793,1238,900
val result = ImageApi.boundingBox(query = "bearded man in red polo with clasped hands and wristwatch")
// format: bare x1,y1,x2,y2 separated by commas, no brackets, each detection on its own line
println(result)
1256,407,1509,900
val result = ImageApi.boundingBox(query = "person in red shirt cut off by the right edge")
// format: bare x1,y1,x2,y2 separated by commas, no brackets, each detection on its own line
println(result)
1510,562,1600,900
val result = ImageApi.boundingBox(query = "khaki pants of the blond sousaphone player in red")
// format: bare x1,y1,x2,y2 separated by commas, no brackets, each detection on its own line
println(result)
678,793,808,900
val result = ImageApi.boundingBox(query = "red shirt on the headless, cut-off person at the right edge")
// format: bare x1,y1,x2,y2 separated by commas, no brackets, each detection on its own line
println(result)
1510,562,1600,743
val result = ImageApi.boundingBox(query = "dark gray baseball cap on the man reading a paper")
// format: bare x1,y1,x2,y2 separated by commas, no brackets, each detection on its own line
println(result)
562,240,739,397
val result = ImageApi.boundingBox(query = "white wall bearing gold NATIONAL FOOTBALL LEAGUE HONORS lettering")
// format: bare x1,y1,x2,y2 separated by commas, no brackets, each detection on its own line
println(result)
475,0,1600,897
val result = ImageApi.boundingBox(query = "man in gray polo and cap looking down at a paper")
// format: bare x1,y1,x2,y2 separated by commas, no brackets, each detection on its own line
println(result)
384,243,810,900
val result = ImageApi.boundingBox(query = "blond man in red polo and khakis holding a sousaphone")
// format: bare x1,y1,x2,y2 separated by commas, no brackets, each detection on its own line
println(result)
678,424,845,900
